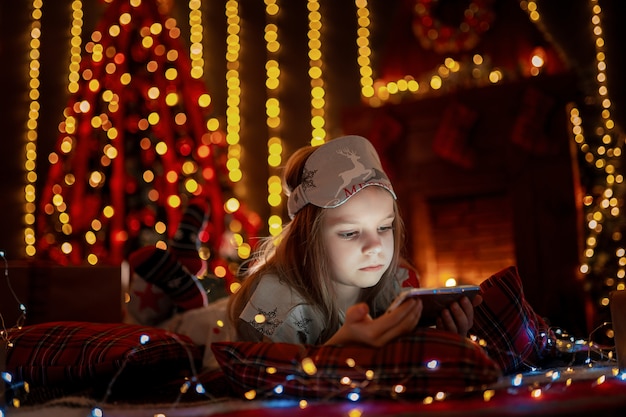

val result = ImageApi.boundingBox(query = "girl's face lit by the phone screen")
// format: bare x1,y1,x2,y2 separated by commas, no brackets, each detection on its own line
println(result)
322,186,395,307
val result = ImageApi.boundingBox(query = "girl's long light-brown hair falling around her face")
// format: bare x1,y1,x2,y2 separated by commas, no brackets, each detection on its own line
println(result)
229,146,404,343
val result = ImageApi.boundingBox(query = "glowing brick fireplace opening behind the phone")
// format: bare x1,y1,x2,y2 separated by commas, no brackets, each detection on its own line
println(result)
408,193,517,287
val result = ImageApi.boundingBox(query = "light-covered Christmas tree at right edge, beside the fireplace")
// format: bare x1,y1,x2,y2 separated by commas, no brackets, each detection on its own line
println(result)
571,104,626,328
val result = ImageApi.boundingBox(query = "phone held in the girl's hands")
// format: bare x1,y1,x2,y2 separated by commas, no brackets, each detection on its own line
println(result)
387,285,480,326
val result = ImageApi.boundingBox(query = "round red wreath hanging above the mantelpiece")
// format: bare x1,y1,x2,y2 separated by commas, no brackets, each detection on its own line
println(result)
412,0,494,53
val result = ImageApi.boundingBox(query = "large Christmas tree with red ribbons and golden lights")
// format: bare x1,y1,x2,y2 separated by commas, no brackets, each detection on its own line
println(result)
37,0,260,290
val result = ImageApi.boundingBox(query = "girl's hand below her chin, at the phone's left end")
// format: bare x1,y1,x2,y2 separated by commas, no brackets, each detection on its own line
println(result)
325,298,422,347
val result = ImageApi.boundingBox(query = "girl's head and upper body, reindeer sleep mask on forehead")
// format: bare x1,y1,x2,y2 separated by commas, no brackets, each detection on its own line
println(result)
229,136,480,346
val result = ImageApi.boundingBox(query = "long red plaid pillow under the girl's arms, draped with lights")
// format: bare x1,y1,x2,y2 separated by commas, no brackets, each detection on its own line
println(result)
211,328,500,398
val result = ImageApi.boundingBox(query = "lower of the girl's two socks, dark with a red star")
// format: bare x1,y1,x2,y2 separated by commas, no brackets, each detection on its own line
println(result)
128,246,208,310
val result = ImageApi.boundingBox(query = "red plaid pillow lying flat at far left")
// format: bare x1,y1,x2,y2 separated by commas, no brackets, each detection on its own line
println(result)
6,322,202,386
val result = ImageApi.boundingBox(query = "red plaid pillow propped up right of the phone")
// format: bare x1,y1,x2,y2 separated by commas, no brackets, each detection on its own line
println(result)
470,266,556,374
